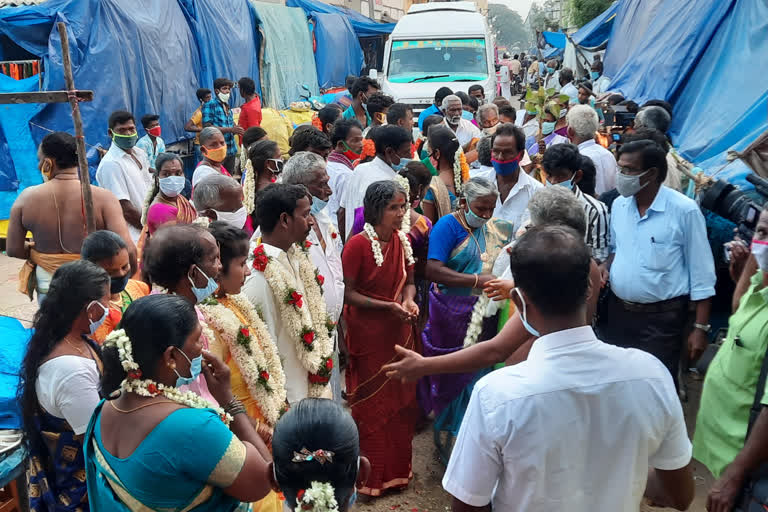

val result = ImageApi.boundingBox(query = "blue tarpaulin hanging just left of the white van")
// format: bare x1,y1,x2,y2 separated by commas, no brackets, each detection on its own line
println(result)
312,13,364,89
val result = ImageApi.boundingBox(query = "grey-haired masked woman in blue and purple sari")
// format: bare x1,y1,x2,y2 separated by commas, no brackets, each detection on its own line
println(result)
419,178,513,460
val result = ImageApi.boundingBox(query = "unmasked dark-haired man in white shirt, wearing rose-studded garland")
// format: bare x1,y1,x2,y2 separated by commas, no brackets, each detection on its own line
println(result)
243,183,331,404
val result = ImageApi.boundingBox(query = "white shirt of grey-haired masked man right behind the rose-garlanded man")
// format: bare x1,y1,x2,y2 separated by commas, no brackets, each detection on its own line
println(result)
307,206,344,322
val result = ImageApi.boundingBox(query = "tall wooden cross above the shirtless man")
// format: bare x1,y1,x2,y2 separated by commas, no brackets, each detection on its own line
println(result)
0,22,96,233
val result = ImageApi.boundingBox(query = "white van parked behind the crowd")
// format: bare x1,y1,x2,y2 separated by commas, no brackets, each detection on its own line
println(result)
370,2,496,112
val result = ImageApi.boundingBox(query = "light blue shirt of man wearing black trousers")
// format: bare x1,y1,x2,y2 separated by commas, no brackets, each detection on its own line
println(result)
610,185,715,304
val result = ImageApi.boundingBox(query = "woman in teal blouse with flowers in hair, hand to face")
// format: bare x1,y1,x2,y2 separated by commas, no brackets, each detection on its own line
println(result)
85,295,272,512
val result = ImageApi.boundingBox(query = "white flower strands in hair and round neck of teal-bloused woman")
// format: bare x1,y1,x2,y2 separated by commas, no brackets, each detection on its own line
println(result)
104,329,232,425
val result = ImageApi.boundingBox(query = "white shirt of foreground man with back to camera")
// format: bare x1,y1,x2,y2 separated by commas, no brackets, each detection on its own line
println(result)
443,326,691,512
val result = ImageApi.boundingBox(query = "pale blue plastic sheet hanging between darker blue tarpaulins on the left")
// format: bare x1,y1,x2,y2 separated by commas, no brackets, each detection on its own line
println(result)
251,1,320,109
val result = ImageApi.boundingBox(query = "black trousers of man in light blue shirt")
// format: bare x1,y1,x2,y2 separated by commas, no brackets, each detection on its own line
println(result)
597,292,689,387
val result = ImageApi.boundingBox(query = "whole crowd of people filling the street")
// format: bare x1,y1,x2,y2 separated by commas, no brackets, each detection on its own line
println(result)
8,67,768,512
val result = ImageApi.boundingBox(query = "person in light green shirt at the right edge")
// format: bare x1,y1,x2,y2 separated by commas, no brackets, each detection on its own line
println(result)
693,209,768,512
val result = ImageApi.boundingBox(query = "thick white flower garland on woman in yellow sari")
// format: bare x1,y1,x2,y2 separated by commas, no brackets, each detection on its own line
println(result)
199,294,286,427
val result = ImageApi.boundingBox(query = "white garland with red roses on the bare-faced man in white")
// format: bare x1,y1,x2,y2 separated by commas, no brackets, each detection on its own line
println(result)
253,244,333,397
